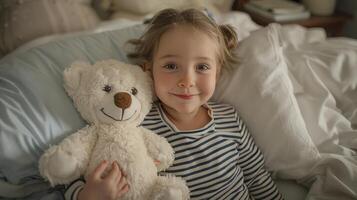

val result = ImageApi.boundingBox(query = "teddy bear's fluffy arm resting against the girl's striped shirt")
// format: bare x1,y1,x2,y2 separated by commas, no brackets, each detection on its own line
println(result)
141,127,175,171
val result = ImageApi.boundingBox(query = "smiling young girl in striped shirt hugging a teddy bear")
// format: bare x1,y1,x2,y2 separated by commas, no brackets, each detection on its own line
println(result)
66,9,282,200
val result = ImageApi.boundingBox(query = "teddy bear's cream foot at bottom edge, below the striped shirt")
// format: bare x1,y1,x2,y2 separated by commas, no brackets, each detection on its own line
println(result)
150,176,190,200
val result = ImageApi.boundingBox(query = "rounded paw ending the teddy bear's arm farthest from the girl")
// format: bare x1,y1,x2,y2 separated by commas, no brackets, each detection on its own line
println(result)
40,148,80,185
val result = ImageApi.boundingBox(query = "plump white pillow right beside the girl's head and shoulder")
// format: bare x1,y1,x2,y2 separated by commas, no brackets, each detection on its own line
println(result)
214,24,319,179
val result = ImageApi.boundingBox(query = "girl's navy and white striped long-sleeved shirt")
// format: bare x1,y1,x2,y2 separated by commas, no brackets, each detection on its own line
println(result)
65,102,283,200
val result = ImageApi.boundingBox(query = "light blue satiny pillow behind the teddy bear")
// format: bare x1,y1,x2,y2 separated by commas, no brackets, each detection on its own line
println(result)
0,25,145,199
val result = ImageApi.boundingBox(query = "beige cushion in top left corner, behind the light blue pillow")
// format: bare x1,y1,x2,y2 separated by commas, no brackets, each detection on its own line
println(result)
0,0,99,55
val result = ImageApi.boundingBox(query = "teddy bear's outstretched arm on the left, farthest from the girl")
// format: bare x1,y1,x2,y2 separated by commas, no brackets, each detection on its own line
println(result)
39,126,97,186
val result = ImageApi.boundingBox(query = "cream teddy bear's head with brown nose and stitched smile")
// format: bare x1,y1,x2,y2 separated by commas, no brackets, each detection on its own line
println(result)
64,60,153,125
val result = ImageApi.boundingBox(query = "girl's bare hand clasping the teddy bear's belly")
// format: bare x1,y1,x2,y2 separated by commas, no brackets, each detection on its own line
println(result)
78,161,129,200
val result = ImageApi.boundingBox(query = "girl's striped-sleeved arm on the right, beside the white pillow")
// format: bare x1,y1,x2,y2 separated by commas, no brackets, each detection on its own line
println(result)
237,117,283,200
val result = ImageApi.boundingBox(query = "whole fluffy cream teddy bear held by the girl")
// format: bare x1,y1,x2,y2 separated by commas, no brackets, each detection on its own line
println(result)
39,59,189,200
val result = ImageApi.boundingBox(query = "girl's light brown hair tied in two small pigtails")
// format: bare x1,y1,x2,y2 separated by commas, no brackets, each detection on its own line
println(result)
128,9,238,72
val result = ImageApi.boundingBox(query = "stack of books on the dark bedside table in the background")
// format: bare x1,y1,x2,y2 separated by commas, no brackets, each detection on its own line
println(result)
244,0,310,22
